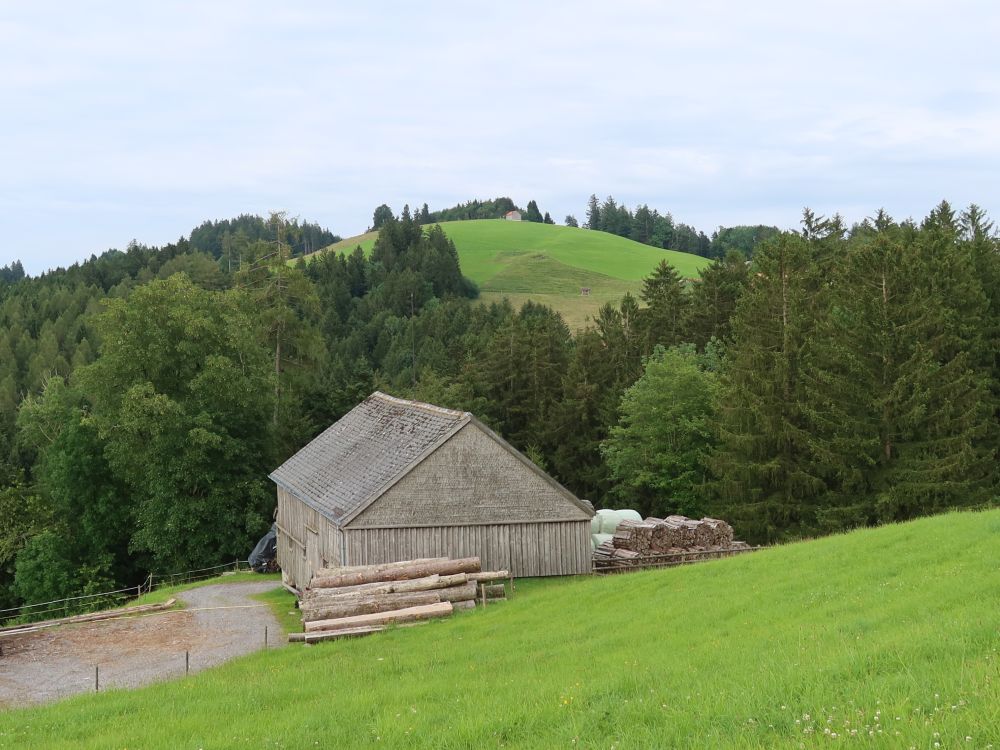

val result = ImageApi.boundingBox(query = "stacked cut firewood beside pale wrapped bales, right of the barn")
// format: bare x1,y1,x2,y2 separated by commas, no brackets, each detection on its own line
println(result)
594,516,750,566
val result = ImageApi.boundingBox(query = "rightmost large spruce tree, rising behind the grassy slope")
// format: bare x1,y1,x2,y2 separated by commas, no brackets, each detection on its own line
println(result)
877,203,996,520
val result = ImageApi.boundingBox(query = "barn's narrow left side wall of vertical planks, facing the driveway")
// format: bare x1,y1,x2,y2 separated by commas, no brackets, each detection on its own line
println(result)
277,487,343,588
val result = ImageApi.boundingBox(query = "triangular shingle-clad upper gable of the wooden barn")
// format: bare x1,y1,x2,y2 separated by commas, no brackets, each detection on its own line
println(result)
345,423,590,528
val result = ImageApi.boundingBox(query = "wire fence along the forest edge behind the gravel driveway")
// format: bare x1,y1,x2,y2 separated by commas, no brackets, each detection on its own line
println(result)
0,560,250,627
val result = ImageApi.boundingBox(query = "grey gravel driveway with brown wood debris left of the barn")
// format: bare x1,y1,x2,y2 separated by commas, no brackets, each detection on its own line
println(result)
0,581,287,707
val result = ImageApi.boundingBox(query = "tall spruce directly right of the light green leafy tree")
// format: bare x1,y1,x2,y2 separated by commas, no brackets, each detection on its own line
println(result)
710,234,825,541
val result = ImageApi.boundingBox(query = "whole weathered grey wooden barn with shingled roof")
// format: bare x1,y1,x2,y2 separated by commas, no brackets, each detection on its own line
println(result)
270,392,594,587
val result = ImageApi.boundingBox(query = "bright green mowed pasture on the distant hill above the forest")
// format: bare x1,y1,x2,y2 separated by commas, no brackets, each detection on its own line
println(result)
308,219,709,329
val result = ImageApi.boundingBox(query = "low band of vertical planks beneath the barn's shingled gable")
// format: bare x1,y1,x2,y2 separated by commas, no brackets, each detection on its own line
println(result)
344,519,591,577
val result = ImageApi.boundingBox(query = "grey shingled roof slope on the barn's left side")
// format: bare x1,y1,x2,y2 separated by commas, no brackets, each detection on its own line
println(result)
270,391,472,525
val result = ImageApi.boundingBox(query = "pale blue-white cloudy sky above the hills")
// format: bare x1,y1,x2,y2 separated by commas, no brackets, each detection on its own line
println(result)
0,0,1000,274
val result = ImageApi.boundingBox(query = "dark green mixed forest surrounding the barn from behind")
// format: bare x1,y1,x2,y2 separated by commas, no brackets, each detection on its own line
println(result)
0,203,1000,607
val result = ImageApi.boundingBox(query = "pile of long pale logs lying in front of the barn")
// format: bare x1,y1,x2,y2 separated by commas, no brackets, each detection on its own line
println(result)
288,557,510,643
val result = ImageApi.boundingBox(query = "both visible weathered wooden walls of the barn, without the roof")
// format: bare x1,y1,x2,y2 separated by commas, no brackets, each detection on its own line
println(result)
278,422,591,587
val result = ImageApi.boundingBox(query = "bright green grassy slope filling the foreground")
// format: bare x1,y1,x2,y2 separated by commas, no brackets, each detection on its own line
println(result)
0,511,1000,748
